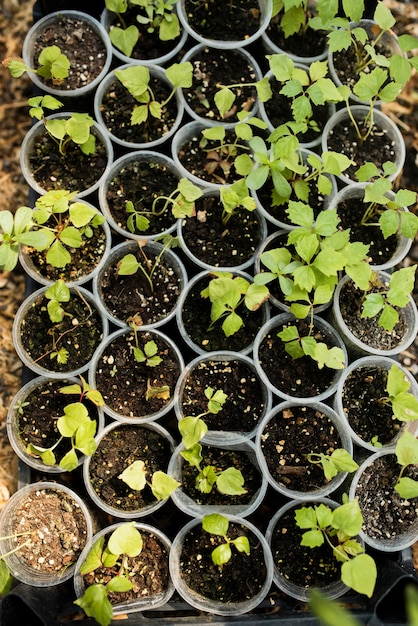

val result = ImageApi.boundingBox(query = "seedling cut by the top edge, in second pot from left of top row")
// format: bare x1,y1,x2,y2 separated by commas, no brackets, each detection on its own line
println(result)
105,0,180,57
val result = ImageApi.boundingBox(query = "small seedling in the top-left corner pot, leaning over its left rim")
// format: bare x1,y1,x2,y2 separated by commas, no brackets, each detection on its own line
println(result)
2,46,70,85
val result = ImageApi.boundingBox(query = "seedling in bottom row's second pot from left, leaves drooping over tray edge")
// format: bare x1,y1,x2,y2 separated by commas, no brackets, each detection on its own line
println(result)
74,522,142,626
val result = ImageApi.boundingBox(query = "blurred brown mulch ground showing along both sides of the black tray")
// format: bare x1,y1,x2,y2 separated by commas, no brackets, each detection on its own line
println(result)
0,0,418,568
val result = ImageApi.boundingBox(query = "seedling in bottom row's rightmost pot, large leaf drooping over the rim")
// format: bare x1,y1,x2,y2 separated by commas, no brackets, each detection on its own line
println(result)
295,500,377,598
